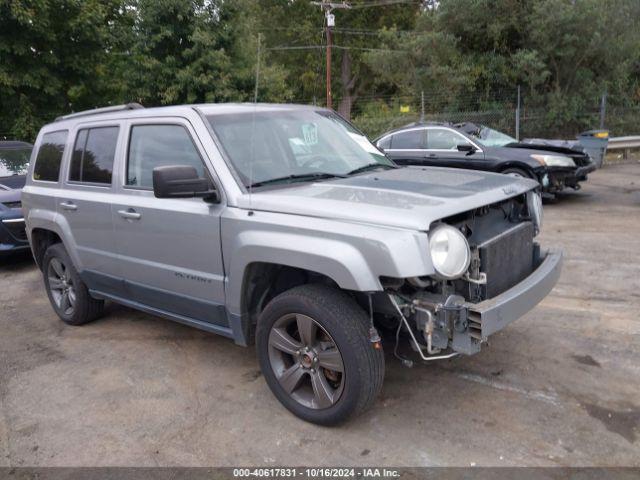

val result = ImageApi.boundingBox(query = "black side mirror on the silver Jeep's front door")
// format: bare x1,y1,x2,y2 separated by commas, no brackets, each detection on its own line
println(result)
153,165,220,203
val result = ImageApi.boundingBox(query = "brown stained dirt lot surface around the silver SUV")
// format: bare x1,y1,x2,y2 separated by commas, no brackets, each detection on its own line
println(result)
0,164,640,466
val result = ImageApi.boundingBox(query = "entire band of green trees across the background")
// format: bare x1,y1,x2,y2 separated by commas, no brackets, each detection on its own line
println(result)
0,0,640,140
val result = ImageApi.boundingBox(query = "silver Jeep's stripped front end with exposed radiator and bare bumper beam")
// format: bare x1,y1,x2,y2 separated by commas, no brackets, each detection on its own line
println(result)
377,192,562,360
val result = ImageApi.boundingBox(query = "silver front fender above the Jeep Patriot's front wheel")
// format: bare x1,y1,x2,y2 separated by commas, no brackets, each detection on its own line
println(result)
222,209,434,315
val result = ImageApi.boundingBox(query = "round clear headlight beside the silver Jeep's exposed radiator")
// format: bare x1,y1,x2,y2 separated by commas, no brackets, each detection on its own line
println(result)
429,225,471,280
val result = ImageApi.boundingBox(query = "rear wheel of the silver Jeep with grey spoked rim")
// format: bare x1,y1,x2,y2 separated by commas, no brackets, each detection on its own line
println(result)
42,243,104,325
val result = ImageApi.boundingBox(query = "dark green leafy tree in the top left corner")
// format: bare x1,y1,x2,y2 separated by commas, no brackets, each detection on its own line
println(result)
0,0,126,139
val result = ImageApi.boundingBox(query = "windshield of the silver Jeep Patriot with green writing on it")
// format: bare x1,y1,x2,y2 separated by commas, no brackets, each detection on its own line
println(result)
207,110,395,186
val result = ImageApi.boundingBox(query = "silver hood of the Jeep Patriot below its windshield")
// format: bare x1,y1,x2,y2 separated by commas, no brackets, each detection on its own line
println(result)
238,167,538,231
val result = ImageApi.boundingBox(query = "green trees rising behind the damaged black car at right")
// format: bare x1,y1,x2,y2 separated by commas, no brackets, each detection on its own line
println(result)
365,0,640,135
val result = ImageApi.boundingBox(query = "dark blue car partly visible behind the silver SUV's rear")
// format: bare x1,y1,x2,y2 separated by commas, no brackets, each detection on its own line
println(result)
0,141,33,257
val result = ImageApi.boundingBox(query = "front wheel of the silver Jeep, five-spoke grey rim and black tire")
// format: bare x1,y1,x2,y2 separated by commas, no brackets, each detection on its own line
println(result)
256,285,384,425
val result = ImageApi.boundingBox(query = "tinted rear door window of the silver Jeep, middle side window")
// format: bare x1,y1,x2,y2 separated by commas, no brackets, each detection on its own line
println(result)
69,127,119,185
